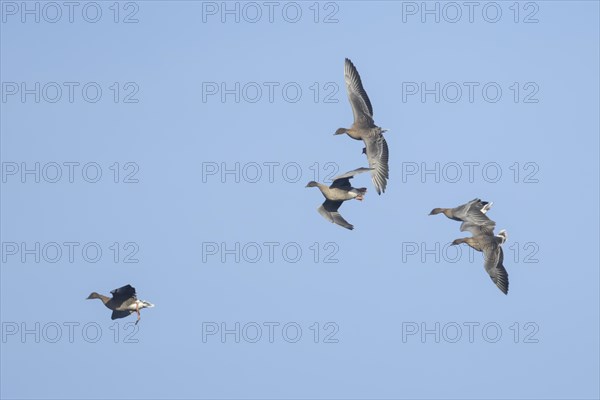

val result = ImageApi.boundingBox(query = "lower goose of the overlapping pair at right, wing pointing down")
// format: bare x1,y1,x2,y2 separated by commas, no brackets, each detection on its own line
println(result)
452,228,508,294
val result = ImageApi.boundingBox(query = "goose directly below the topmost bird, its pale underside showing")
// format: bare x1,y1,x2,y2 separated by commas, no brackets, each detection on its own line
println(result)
306,168,371,229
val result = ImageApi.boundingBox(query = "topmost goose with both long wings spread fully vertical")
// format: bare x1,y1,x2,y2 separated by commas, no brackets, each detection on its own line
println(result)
335,58,389,194
